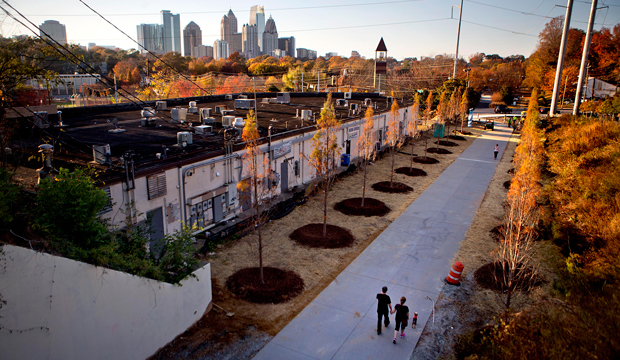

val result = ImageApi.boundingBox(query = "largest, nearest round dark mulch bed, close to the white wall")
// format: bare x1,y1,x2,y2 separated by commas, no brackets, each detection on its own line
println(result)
226,267,304,304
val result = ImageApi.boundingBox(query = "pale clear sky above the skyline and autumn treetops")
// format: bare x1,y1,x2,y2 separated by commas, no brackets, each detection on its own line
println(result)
0,0,620,60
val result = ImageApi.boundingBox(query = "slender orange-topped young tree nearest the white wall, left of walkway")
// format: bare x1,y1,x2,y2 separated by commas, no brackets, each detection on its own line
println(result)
237,110,273,284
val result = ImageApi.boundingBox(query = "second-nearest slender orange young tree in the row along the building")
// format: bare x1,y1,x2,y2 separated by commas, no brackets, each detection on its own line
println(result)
308,93,340,236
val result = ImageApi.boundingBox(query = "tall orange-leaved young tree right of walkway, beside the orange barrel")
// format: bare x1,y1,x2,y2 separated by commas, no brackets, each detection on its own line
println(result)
496,90,543,309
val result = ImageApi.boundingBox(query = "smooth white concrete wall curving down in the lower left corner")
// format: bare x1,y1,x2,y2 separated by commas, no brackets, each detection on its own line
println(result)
0,245,212,360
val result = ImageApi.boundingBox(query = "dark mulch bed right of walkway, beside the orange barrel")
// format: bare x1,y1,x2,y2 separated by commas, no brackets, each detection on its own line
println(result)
474,262,542,292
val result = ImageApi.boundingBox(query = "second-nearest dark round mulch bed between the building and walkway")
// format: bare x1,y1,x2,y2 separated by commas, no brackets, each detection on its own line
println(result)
289,224,355,249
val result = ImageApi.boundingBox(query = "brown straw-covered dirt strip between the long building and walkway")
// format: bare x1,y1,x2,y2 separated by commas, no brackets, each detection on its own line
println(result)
151,128,484,360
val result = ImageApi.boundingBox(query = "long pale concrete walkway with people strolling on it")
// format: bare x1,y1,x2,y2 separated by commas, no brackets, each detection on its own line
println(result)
254,123,512,360
